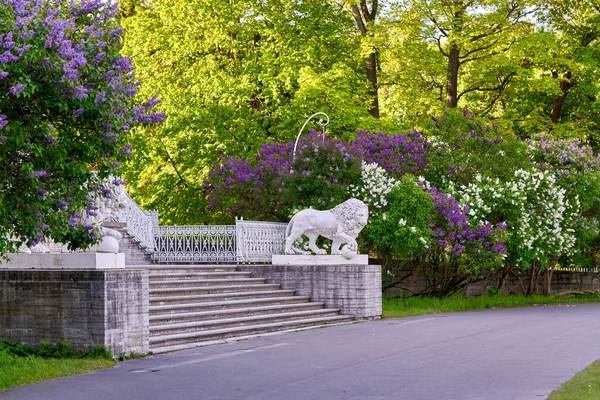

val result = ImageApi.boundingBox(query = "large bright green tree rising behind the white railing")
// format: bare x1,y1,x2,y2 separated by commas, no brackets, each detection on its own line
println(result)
123,0,371,223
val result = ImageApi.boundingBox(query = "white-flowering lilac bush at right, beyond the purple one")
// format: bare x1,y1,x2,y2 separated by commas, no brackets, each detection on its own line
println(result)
449,170,579,268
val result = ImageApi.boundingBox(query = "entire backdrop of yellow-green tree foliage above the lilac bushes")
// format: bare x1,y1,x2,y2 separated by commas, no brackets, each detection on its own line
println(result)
119,0,600,223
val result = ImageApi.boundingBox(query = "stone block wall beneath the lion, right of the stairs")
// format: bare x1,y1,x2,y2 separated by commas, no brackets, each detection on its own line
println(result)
240,265,381,319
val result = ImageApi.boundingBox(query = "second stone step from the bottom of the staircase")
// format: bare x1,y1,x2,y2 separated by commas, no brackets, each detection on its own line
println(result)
150,308,340,337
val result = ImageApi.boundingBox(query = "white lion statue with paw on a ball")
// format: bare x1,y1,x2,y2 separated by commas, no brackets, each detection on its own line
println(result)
285,199,369,258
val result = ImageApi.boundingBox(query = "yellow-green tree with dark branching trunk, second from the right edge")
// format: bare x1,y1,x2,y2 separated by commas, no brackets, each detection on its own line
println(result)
382,0,534,122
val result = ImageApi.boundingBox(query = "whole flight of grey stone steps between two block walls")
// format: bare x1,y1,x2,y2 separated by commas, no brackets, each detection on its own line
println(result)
149,265,354,354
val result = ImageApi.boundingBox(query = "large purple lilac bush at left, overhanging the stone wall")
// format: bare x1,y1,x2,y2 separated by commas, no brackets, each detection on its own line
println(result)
0,0,164,254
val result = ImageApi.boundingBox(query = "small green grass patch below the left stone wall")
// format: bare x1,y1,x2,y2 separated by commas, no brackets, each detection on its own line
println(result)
0,350,116,390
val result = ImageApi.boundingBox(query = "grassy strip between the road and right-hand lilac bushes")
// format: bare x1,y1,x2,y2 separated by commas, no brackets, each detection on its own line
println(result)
383,295,600,318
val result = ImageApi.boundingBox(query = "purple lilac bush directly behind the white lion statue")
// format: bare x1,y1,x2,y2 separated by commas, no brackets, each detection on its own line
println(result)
204,131,360,221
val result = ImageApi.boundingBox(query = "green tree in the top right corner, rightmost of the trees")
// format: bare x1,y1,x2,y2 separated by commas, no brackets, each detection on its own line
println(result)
505,0,600,147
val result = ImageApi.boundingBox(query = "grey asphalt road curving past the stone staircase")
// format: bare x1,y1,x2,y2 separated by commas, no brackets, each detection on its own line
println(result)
0,304,600,400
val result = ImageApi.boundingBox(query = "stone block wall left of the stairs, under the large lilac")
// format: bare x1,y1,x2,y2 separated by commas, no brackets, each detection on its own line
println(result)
0,269,149,356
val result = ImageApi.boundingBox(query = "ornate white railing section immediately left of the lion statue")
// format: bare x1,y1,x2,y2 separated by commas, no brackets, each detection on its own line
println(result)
236,220,287,263
